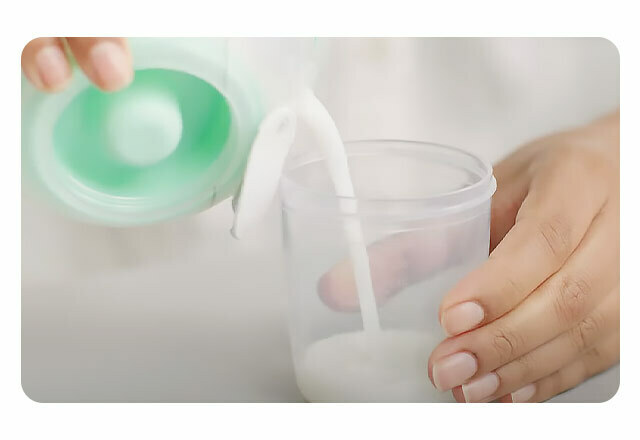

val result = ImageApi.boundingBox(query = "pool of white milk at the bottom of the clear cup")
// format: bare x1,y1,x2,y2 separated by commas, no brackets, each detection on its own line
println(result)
296,330,453,402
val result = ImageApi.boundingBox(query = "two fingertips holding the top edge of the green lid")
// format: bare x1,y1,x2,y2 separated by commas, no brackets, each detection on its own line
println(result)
22,37,133,92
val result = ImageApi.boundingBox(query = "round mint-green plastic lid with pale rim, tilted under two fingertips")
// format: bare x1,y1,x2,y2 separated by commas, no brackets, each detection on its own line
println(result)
23,39,262,226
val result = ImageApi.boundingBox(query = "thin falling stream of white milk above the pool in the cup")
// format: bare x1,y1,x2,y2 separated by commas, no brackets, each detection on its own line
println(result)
298,91,380,333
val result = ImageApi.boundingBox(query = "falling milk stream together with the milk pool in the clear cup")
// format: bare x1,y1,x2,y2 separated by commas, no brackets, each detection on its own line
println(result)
295,92,442,402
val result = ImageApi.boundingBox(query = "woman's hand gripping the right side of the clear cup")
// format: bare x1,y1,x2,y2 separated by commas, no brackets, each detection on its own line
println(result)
428,113,620,402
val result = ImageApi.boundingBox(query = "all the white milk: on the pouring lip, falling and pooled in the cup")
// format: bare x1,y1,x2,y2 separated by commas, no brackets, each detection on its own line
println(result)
234,90,443,401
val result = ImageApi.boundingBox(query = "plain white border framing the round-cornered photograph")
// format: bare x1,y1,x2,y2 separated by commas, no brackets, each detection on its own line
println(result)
1,2,638,438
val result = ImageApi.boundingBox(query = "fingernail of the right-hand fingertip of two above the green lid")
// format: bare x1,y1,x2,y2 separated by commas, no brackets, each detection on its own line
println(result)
90,41,133,90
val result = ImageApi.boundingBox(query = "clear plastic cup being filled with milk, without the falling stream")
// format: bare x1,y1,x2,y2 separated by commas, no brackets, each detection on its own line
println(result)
281,140,496,402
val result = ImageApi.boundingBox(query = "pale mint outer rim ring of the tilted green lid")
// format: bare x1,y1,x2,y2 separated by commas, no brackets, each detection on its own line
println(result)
23,42,263,226
